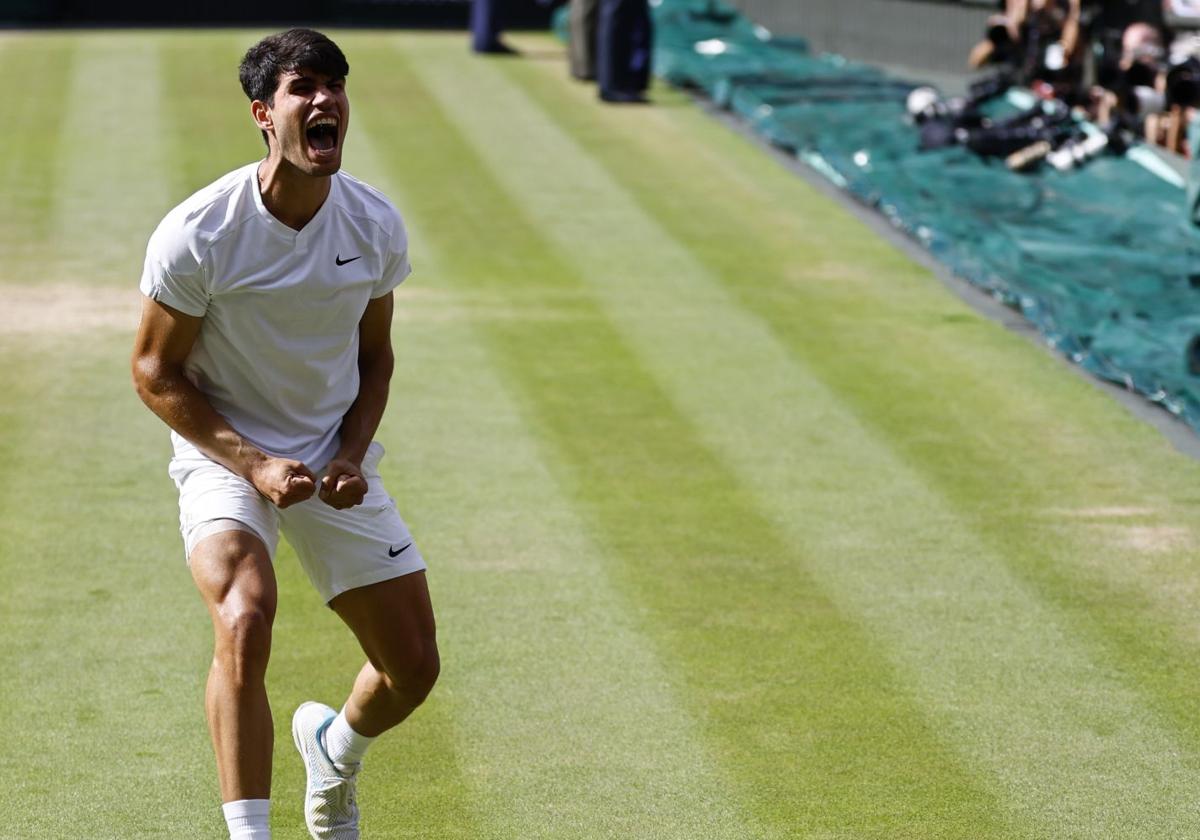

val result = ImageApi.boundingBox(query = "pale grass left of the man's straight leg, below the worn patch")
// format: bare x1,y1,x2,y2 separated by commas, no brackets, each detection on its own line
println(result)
0,331,212,840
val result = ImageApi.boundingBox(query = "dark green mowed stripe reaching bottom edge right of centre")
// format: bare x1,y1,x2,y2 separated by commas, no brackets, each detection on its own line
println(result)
352,38,1022,836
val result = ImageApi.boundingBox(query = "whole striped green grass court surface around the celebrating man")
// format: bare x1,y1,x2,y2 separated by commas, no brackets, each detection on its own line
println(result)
0,31,1200,839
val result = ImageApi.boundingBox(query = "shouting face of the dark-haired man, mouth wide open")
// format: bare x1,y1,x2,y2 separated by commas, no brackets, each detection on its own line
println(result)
256,68,350,175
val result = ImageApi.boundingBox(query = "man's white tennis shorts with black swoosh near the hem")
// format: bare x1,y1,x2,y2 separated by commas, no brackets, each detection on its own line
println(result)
169,442,425,604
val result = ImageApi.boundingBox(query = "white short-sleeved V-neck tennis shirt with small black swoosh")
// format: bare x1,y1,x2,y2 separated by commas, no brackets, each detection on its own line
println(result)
140,163,412,470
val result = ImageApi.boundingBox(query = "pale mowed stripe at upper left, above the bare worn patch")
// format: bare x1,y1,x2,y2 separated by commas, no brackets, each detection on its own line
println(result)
52,32,170,289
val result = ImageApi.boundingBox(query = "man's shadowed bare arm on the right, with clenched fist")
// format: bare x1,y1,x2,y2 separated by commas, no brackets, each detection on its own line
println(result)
318,292,395,510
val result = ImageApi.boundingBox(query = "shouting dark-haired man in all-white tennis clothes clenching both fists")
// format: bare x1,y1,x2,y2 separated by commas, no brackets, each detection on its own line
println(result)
133,29,438,840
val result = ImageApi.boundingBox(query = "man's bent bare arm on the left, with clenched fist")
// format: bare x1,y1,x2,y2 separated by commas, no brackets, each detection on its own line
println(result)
133,291,317,508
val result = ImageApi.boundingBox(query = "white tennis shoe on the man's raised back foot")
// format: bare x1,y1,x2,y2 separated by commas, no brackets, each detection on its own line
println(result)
292,702,360,840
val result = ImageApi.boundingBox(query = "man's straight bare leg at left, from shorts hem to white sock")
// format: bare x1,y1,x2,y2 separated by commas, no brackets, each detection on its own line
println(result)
190,530,277,803
